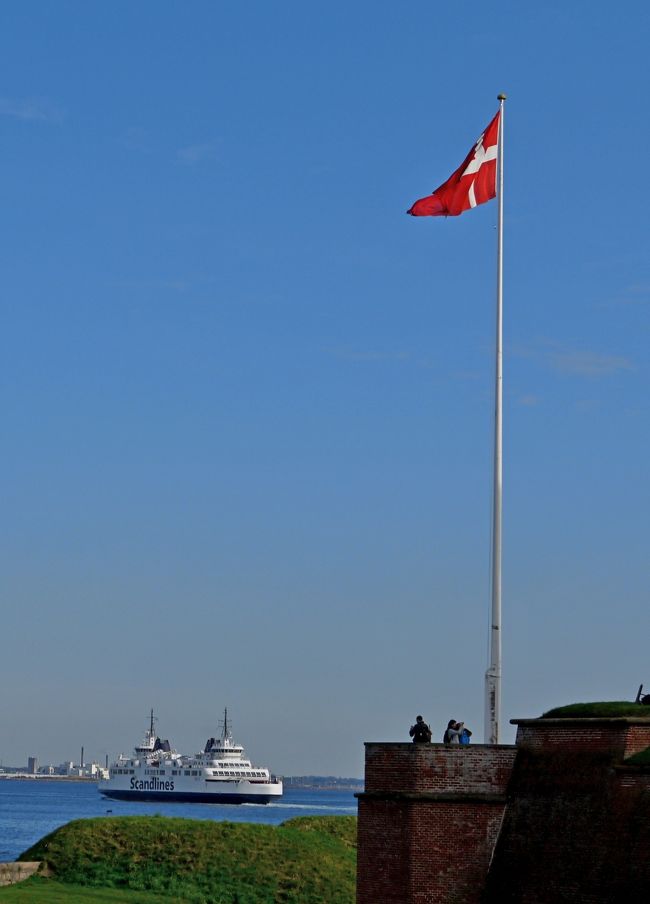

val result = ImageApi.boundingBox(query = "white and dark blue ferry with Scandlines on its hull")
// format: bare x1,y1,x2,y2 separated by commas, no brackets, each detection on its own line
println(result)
98,709,282,804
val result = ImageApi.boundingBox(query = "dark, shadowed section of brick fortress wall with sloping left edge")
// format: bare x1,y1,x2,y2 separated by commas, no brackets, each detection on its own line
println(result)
483,719,650,904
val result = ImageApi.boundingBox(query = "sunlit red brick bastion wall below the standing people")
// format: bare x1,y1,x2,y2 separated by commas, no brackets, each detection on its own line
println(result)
357,744,515,904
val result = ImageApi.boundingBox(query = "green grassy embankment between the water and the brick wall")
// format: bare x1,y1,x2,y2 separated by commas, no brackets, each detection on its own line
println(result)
0,816,356,904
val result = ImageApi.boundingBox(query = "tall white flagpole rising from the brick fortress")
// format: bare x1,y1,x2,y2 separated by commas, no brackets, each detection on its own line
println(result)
485,94,506,744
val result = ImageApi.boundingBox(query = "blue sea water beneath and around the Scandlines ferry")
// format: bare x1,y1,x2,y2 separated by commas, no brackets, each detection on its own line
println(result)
0,779,357,862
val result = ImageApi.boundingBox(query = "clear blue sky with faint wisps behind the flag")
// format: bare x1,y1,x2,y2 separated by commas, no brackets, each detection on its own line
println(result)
0,0,650,775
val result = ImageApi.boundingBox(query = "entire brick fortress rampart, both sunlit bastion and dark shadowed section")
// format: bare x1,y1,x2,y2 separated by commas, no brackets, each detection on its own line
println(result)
357,718,650,904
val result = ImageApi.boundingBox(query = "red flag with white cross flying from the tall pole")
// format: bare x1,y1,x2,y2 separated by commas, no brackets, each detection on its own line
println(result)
406,111,501,217
